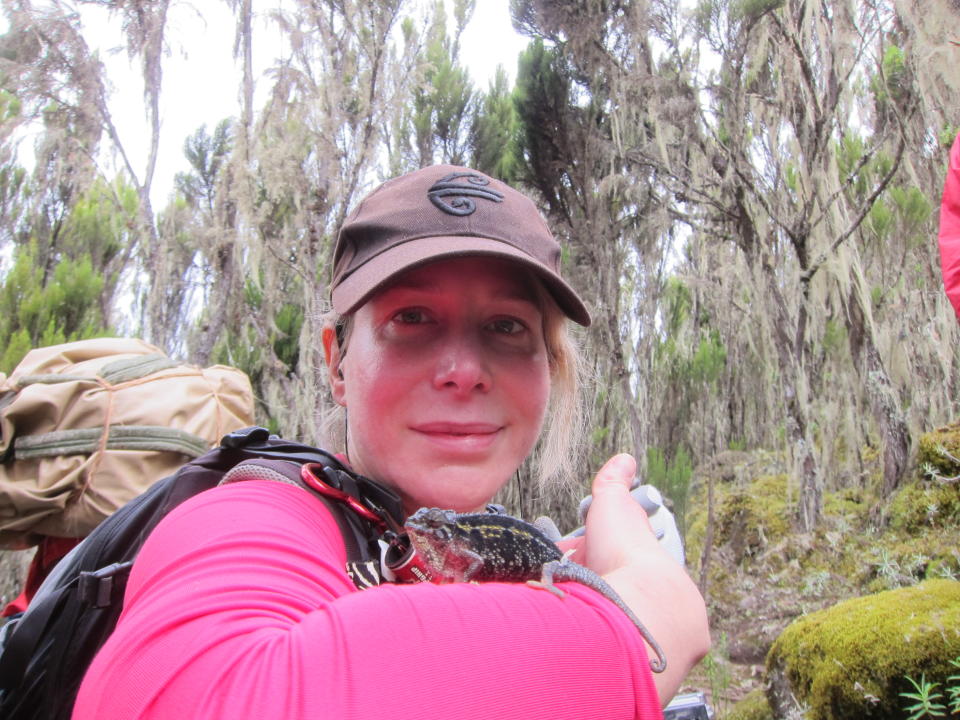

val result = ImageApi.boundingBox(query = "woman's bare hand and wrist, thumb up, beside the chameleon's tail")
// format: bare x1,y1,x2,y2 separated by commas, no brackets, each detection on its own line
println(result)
573,454,710,705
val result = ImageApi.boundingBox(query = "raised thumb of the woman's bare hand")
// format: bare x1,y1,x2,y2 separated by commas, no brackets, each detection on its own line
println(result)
585,453,657,575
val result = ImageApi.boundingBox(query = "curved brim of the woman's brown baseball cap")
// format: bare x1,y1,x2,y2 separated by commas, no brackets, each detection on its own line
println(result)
331,235,590,327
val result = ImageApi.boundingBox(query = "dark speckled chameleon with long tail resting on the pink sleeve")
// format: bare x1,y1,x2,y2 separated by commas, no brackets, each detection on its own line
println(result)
404,508,667,672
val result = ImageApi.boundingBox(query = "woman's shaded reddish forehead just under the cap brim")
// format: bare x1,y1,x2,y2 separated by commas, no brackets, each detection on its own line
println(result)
374,256,541,306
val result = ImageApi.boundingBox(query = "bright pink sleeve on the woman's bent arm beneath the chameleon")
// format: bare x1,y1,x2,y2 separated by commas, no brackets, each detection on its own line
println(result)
73,481,662,720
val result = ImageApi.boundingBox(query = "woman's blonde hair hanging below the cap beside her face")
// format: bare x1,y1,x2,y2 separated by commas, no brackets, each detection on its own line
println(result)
320,276,587,487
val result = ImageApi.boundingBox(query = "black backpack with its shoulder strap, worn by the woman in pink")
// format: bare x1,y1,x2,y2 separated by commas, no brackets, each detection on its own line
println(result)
0,428,402,720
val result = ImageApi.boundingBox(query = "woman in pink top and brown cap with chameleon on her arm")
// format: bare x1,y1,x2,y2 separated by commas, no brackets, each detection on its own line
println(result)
74,166,709,720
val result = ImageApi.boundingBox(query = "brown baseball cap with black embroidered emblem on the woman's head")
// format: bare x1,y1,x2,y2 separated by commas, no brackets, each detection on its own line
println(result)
331,165,590,325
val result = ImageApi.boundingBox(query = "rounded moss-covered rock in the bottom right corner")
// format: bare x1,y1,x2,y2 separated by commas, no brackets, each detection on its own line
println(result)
766,580,960,720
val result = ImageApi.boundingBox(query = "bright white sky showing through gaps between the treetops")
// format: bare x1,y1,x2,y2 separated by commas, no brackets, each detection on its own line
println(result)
73,0,527,210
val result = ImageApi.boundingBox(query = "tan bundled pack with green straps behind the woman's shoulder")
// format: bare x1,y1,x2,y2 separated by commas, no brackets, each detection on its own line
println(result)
0,338,253,549
